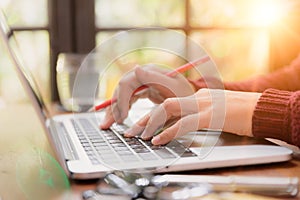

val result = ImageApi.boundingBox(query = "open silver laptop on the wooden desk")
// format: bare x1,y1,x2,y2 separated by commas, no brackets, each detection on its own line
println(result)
0,12,292,179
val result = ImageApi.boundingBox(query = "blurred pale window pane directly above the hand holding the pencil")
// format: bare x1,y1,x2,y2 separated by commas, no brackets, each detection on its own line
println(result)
96,30,186,98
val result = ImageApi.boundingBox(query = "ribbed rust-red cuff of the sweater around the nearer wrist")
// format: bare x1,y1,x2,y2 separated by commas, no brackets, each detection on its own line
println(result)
252,89,293,143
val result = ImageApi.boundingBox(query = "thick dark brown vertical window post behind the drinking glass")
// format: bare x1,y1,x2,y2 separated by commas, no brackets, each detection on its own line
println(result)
48,0,95,101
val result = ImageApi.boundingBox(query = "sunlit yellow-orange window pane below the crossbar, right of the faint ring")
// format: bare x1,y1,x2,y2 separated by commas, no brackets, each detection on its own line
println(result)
191,30,269,81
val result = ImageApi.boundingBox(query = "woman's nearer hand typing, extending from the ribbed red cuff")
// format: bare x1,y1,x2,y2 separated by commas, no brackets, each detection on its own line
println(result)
125,89,261,145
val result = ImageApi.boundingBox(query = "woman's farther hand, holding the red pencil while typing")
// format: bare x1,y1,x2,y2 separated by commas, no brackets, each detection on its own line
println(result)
100,65,195,129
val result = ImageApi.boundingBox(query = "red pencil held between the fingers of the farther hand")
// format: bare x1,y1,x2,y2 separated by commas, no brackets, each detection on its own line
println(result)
89,56,210,112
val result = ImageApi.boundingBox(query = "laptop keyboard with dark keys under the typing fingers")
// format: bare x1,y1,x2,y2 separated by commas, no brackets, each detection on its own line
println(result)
71,118,196,164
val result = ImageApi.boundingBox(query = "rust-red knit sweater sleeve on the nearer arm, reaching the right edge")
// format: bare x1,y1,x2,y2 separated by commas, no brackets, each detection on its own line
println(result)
252,89,300,147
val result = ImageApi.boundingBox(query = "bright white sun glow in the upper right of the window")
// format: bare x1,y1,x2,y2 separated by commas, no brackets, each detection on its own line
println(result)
252,0,285,26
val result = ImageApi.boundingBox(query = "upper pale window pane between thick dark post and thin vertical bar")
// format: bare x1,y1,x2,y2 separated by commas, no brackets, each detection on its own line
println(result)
95,0,185,28
